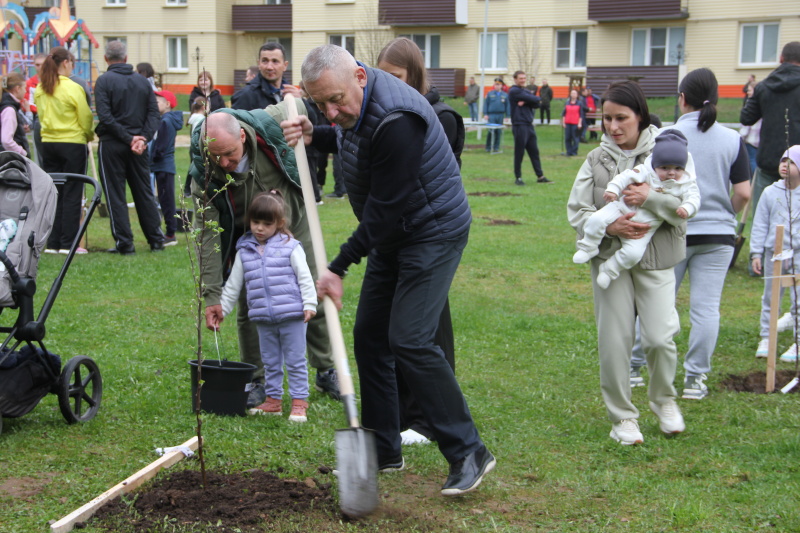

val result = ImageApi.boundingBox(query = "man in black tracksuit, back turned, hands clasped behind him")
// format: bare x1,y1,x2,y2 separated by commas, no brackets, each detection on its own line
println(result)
94,41,164,255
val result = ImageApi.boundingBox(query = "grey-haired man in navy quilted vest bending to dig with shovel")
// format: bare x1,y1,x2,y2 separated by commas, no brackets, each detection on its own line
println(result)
281,45,495,496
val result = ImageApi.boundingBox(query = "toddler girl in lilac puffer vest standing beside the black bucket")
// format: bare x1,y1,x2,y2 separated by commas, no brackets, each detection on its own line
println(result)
215,189,317,422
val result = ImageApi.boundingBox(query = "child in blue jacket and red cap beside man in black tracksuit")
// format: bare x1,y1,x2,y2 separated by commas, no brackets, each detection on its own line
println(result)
150,91,183,246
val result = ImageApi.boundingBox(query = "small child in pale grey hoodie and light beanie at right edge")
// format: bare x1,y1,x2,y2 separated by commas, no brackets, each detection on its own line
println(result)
750,145,800,362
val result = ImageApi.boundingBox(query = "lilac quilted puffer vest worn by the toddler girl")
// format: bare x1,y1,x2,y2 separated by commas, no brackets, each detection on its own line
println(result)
236,231,303,324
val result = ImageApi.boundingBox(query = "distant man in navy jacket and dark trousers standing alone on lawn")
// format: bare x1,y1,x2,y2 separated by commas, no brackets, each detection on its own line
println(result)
508,70,552,185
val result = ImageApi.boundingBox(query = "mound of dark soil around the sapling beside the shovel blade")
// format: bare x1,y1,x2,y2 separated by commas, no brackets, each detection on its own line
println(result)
92,470,338,531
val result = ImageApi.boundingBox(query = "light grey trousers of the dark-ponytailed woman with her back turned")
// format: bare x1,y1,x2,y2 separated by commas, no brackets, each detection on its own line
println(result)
631,244,733,376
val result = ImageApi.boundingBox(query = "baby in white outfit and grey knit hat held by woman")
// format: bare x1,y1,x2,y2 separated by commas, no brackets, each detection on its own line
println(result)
572,130,700,289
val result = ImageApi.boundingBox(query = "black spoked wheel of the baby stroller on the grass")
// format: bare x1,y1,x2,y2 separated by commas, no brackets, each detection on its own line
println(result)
58,355,103,424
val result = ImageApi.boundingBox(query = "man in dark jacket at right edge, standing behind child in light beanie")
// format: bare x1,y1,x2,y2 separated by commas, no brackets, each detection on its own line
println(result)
739,41,800,211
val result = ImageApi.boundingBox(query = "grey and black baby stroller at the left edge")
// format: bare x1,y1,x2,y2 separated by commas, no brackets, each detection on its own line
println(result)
0,152,103,433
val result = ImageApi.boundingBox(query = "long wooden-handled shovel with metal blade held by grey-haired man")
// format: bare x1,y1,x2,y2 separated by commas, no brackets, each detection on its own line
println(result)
284,94,378,518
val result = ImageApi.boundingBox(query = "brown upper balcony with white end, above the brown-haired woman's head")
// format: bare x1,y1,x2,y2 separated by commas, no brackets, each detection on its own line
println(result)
378,0,468,26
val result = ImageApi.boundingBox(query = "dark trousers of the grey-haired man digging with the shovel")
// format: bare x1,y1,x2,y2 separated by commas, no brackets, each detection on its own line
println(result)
353,234,482,464
